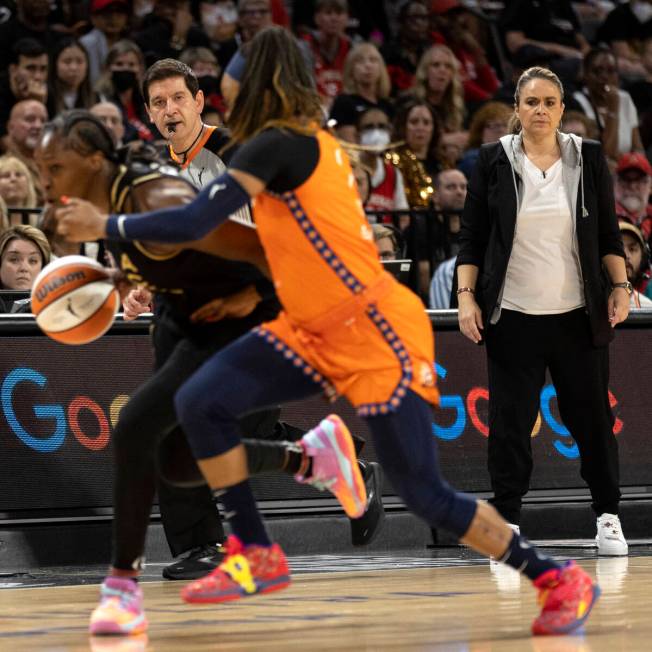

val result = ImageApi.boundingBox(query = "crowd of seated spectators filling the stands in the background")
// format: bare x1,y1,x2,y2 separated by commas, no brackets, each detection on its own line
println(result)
0,0,652,308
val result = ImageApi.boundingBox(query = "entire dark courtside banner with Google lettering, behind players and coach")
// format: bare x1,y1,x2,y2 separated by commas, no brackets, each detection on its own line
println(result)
0,324,652,513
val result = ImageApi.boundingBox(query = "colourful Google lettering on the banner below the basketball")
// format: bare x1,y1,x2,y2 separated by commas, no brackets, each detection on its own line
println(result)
0,367,129,453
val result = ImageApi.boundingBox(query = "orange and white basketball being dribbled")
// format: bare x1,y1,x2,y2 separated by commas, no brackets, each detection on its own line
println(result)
32,256,120,344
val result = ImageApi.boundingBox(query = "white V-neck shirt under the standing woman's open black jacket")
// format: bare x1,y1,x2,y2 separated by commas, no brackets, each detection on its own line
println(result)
501,156,584,315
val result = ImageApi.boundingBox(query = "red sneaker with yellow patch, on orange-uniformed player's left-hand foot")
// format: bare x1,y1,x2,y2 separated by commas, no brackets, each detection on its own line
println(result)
181,535,290,603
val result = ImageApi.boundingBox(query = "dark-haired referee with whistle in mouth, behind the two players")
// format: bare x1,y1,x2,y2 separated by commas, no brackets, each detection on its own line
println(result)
131,59,385,579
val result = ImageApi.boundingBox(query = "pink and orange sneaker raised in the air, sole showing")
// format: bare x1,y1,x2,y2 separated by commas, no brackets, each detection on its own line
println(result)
294,414,367,518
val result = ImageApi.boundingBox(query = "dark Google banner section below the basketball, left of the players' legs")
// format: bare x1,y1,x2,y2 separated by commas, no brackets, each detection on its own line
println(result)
0,335,152,512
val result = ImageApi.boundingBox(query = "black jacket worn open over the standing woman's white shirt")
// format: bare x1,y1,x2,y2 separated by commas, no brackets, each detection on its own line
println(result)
457,135,624,346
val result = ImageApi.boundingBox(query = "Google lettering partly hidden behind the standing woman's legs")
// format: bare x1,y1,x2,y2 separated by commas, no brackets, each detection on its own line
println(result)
432,362,623,459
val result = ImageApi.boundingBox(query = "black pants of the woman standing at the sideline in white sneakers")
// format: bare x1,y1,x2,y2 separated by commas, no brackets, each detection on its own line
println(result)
486,309,620,524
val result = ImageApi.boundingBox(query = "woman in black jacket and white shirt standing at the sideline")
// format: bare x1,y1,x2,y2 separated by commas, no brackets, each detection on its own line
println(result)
457,68,631,555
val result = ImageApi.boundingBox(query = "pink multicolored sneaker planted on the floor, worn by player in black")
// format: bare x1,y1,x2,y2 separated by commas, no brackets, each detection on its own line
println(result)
89,577,147,635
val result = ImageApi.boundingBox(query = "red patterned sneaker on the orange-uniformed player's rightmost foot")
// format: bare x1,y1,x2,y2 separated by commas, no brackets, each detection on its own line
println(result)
532,561,600,635
